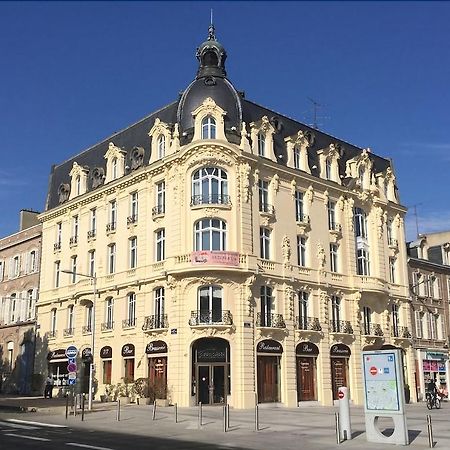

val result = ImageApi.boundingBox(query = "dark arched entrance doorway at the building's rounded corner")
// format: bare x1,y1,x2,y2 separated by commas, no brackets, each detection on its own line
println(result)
191,338,231,405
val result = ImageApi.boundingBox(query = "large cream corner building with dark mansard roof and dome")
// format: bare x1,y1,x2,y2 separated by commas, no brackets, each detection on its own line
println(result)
38,26,414,408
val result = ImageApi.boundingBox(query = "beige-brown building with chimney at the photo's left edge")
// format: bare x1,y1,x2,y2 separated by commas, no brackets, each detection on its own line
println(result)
0,210,42,394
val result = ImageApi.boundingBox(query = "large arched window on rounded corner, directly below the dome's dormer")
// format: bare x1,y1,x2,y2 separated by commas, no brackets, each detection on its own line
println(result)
191,167,230,205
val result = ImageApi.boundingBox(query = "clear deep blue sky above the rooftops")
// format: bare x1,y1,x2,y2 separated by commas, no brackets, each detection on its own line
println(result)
0,1,450,239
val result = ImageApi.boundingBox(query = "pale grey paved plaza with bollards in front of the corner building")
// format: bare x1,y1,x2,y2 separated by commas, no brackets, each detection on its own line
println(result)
0,399,450,450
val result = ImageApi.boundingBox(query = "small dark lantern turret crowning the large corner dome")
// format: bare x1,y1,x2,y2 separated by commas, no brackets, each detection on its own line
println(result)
196,24,227,80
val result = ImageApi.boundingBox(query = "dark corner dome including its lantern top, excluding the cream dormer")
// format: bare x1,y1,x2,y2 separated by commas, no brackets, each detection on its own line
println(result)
177,25,242,145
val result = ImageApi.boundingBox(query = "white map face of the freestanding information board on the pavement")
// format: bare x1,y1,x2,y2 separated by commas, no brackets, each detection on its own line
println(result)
363,353,400,411
